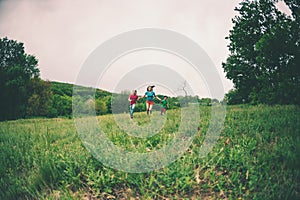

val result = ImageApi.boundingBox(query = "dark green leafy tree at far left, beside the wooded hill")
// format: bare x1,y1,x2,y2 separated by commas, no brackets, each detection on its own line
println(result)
0,37,39,120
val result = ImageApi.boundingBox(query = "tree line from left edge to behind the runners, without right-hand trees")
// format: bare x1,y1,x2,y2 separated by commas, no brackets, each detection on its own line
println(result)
0,37,217,120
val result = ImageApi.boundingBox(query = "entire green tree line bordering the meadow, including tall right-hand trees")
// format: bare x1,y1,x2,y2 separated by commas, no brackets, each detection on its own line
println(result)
0,0,300,120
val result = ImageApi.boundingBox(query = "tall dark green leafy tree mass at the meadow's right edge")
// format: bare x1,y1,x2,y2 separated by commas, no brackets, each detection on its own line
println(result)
223,0,300,104
